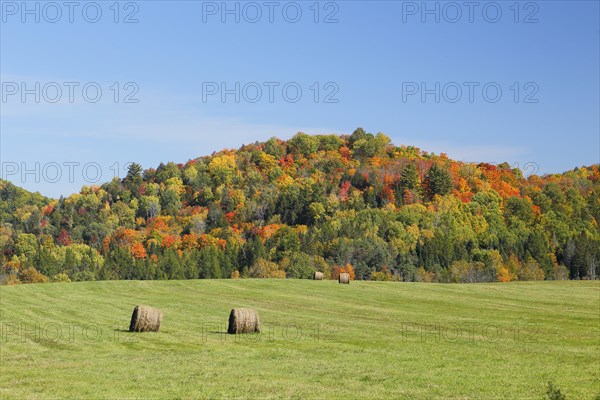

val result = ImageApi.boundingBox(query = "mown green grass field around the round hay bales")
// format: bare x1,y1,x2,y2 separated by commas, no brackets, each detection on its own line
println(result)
0,280,600,399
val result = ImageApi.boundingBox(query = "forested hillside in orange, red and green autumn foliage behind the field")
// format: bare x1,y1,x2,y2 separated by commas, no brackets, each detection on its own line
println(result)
0,128,600,284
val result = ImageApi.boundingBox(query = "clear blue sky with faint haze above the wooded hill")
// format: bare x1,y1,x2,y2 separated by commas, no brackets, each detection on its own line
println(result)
0,0,600,197
